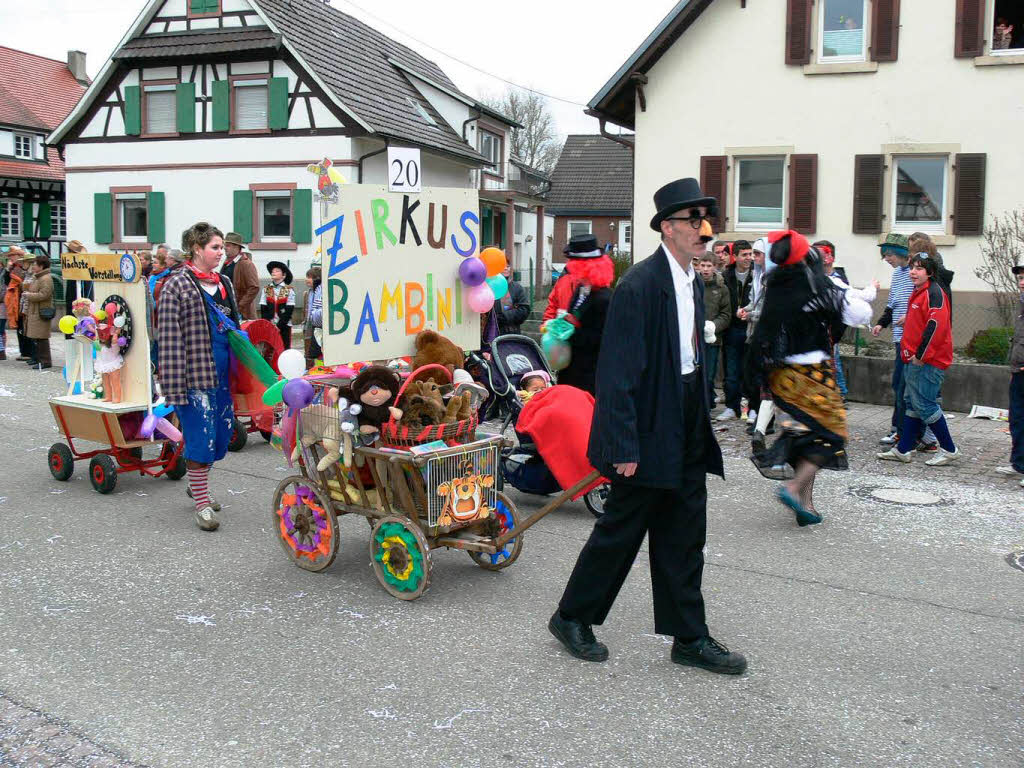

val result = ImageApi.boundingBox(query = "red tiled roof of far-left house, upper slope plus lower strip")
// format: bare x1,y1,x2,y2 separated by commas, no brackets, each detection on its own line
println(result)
0,45,85,181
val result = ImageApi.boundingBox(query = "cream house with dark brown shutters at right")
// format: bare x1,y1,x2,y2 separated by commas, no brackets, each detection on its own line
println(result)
589,0,1024,327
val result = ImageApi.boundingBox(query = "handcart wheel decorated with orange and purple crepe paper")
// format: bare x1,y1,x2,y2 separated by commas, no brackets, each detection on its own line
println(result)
273,475,338,571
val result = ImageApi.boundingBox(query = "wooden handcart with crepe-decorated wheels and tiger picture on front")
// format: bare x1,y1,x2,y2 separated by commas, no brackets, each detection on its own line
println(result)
272,374,599,600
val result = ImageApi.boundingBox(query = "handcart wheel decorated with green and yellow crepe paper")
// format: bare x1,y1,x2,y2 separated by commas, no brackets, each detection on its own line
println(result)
370,515,430,600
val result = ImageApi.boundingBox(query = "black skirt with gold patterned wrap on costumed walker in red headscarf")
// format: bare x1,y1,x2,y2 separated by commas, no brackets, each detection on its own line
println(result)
754,360,849,476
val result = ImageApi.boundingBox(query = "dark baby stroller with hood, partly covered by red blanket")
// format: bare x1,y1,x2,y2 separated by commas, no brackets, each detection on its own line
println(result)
473,334,609,517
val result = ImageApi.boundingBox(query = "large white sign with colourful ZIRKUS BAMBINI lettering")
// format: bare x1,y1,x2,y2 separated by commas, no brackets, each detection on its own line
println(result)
316,184,480,366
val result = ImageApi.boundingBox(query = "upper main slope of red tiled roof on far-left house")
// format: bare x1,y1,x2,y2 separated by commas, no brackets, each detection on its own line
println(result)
0,45,85,131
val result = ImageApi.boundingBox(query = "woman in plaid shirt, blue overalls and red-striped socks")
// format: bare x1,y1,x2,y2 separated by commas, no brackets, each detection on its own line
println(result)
157,221,242,530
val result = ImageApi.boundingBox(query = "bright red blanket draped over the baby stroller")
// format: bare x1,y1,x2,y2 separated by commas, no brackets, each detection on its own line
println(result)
516,386,604,499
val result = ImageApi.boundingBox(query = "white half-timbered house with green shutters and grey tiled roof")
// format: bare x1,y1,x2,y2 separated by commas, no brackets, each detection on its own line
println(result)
48,0,550,288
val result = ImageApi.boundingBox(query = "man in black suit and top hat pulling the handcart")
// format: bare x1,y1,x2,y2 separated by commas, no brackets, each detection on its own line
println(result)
548,178,746,675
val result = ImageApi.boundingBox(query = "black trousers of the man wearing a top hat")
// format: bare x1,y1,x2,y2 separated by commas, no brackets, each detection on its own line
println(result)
558,375,708,641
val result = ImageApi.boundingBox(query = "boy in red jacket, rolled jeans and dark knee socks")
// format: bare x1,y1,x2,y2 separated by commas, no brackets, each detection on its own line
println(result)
877,253,962,467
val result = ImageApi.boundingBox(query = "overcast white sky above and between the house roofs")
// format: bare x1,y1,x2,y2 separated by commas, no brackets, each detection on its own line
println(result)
0,0,675,134
